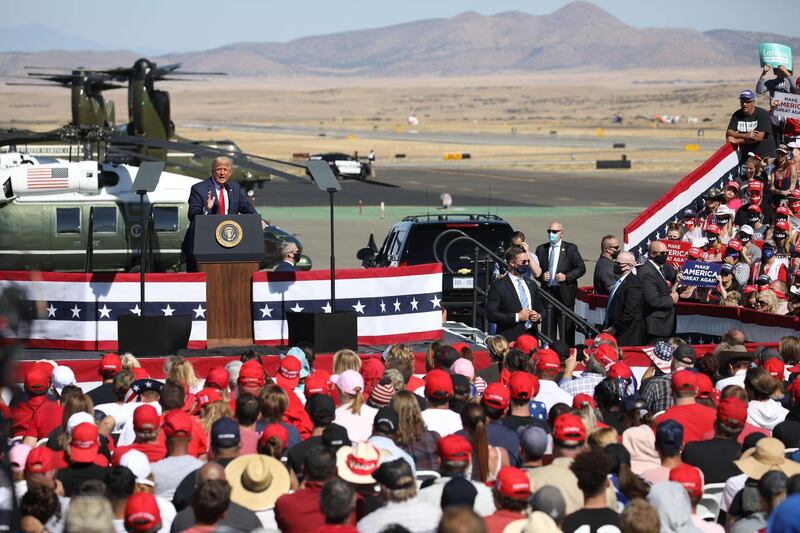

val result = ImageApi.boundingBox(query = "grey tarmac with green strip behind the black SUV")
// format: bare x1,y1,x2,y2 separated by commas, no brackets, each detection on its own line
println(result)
256,163,682,274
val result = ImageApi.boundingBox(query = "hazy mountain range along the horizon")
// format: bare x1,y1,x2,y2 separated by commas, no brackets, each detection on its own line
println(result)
0,1,800,76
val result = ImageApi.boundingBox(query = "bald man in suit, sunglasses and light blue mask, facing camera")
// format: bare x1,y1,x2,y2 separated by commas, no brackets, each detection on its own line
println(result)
536,222,586,346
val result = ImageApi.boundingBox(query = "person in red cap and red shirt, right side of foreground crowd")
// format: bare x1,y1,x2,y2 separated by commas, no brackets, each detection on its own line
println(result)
656,370,717,445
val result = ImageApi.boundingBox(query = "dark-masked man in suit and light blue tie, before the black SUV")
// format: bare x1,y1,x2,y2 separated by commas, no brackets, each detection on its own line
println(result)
486,246,544,341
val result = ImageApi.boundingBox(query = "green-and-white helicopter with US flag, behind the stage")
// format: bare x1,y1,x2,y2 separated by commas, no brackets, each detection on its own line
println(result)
0,126,311,272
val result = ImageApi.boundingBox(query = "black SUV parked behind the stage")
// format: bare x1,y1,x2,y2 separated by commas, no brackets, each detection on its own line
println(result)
357,213,514,326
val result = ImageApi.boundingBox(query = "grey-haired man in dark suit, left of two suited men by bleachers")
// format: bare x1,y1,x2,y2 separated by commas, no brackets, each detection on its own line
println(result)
603,252,644,346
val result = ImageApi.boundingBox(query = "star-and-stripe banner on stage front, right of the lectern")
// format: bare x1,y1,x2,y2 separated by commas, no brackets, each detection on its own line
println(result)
253,264,442,345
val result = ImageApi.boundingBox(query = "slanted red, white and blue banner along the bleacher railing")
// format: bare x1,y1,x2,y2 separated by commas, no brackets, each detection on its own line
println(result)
625,144,739,257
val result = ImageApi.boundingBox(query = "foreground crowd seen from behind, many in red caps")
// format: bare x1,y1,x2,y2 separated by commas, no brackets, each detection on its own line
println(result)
0,330,800,533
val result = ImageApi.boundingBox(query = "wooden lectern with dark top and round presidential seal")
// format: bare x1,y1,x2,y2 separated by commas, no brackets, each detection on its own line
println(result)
191,215,264,348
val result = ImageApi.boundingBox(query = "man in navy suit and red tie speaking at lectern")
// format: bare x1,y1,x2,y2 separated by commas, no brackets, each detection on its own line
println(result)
181,156,266,270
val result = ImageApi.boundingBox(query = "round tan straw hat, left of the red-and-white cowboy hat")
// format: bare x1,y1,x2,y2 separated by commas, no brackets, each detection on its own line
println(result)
225,454,289,512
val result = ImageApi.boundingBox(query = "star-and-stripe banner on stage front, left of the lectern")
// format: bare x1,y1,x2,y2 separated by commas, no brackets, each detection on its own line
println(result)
0,271,206,350
